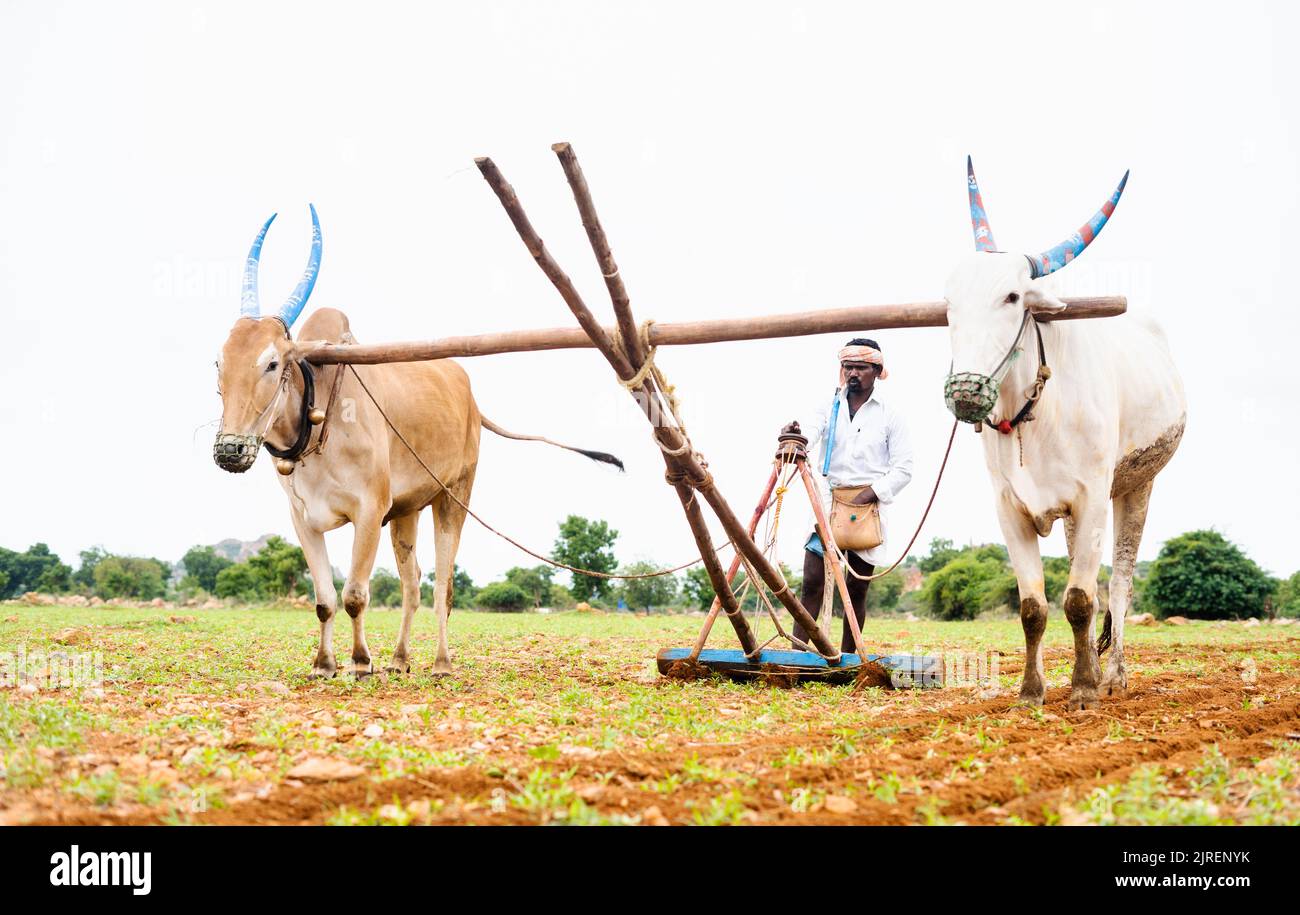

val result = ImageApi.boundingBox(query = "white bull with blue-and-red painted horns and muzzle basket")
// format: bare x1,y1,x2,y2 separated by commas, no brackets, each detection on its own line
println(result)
945,161,1187,710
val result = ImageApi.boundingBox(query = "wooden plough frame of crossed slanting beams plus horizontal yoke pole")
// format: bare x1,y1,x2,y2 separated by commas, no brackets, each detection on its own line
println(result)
302,143,1127,668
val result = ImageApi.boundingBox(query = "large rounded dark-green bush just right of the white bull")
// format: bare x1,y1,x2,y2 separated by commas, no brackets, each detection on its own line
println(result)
1143,530,1274,619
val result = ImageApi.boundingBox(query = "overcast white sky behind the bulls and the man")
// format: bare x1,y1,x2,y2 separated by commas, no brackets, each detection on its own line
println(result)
0,0,1300,582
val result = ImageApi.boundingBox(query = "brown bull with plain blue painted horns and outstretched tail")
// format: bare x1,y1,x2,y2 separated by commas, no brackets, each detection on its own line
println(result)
213,208,621,677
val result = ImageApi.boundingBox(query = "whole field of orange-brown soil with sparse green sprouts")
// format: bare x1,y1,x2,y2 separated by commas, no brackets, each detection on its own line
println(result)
0,608,1300,825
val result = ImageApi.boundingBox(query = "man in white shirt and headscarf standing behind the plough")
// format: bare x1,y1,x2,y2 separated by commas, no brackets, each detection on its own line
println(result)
781,337,911,652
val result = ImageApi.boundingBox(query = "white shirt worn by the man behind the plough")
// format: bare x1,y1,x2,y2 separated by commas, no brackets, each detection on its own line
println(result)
800,382,913,565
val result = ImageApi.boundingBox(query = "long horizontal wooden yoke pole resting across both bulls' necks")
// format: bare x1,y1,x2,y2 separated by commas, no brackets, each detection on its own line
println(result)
298,295,1128,365
